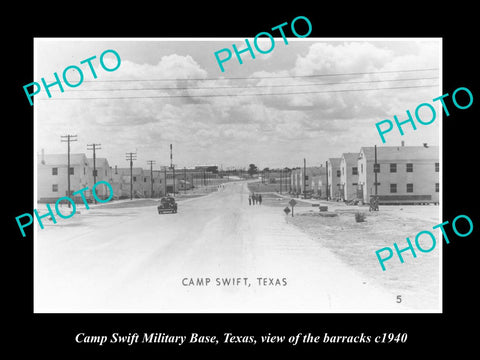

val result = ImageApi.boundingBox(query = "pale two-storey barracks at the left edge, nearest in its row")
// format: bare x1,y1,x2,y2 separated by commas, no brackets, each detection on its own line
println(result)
37,152,93,203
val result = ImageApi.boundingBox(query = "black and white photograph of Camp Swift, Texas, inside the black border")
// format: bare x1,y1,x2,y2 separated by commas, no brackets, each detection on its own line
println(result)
31,37,442,313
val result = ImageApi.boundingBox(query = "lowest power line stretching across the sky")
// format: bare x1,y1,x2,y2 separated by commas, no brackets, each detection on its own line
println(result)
39,84,438,101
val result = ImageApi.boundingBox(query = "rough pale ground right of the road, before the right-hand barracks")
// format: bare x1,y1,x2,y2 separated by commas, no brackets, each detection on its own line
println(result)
253,193,443,311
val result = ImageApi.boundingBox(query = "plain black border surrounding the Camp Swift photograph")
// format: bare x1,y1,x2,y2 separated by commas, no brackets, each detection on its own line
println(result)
2,2,480,357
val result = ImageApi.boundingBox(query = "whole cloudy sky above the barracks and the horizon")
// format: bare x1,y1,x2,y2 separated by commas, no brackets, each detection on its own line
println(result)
32,38,442,168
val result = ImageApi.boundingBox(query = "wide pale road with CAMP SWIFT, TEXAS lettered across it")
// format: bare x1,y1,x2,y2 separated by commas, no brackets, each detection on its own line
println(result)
35,182,406,312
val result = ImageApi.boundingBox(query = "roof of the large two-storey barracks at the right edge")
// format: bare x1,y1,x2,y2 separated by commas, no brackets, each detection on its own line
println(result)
360,146,440,161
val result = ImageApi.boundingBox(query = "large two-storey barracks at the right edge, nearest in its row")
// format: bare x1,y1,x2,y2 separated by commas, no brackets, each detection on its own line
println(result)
358,146,440,204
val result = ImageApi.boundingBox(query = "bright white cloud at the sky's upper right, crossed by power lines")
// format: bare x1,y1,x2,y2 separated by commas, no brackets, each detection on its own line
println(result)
291,42,440,119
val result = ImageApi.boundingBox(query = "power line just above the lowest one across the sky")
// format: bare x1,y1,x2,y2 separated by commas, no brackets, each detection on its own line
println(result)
50,76,438,92
